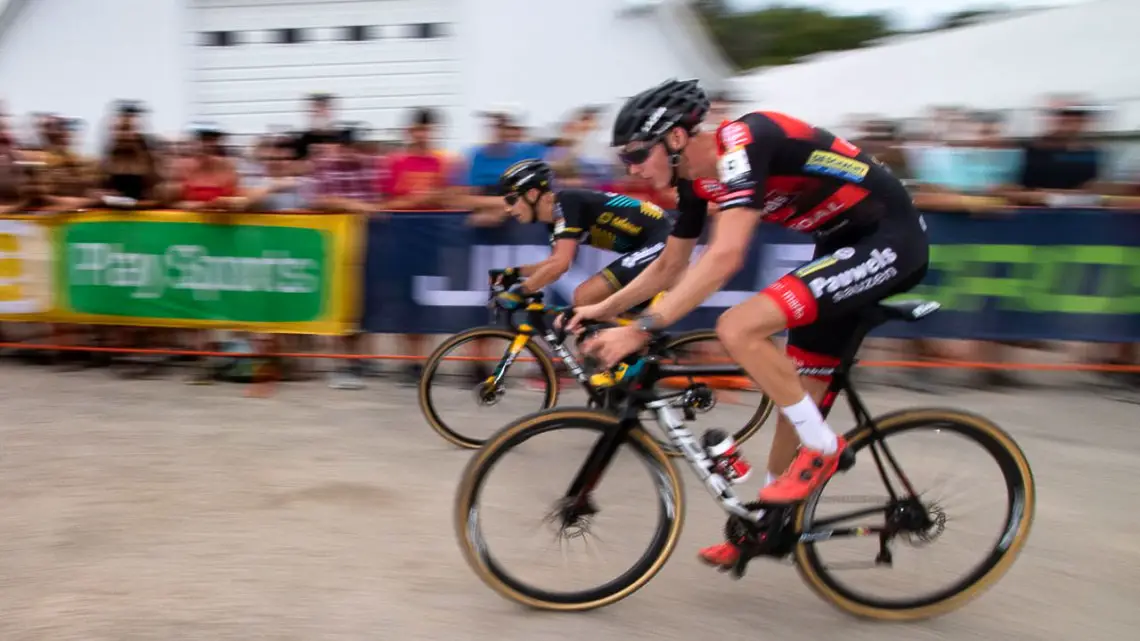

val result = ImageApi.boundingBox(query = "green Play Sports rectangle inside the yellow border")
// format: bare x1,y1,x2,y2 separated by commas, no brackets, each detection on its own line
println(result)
59,221,329,323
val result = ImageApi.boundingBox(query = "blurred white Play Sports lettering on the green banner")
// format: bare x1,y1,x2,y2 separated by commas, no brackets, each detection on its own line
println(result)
67,243,319,301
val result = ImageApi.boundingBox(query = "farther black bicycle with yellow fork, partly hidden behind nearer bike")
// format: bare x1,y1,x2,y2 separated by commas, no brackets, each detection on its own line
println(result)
418,271,773,447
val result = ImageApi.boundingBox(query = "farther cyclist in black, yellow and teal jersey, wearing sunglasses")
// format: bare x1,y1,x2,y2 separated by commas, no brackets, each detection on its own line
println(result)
498,159,673,309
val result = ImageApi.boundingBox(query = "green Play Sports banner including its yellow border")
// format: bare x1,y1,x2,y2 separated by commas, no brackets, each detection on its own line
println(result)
43,212,360,334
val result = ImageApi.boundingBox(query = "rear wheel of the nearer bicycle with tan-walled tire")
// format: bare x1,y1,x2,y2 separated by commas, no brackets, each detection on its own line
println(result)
795,409,1036,620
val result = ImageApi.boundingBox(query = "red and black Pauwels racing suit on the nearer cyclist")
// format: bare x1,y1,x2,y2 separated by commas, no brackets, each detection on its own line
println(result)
673,112,929,372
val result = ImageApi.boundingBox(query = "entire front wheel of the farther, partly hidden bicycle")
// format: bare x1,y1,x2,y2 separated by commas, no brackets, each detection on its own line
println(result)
418,326,559,449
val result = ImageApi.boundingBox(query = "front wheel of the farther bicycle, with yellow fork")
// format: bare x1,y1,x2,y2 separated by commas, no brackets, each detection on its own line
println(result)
418,326,559,449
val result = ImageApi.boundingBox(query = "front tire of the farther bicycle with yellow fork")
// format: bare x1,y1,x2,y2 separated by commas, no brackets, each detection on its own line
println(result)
417,325,559,449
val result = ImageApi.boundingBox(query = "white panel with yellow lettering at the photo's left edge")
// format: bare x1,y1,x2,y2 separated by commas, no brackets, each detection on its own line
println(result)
0,220,55,314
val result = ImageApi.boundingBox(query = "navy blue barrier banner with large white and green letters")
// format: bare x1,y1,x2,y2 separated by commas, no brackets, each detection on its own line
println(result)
363,210,1140,342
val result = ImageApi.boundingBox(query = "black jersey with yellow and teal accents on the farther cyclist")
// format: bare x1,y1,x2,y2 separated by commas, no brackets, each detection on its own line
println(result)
551,189,673,253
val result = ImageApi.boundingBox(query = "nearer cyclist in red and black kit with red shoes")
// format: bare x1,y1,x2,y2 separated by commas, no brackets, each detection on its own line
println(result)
571,80,929,567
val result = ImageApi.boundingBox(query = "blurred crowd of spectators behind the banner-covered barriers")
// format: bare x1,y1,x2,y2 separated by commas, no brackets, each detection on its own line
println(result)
0,90,1140,389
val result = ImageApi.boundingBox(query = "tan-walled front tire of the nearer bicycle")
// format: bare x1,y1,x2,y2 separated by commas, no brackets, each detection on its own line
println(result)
454,407,685,611
